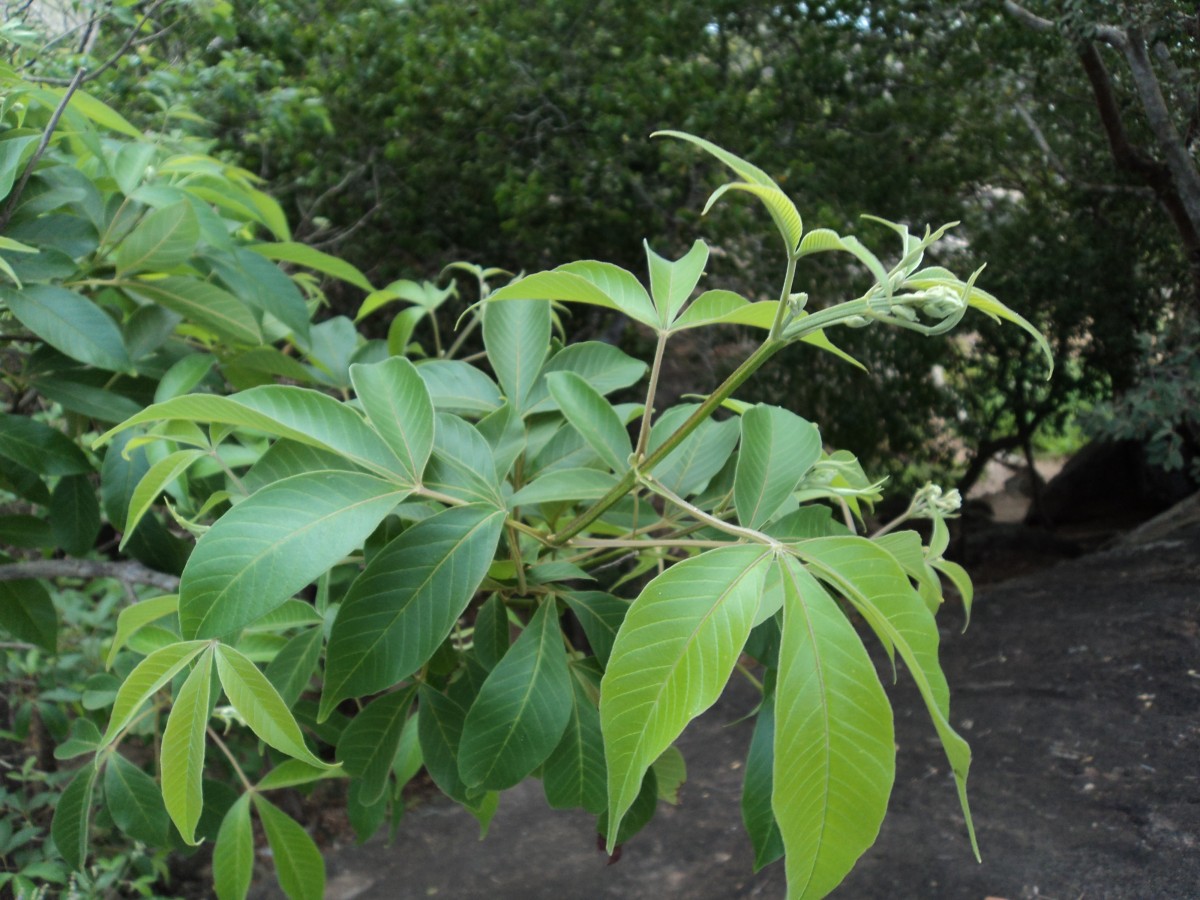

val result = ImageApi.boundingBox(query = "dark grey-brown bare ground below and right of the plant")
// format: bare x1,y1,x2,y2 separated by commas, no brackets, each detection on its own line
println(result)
257,501,1200,900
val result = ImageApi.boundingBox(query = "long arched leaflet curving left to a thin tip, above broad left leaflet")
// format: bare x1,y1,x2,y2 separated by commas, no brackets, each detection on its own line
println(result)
96,384,404,487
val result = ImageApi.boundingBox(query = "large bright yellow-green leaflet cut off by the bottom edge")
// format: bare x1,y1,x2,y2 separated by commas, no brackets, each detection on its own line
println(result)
772,558,895,899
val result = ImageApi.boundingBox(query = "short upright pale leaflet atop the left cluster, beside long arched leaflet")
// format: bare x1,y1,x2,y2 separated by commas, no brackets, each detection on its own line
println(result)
350,356,433,485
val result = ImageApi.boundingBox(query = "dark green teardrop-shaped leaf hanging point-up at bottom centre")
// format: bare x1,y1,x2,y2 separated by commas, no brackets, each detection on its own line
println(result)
458,599,571,791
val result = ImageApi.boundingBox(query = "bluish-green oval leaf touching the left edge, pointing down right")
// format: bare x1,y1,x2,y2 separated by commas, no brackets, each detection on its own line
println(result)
0,284,133,372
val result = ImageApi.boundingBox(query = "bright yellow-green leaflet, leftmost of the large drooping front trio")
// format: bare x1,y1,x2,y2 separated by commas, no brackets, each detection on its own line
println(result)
600,545,772,853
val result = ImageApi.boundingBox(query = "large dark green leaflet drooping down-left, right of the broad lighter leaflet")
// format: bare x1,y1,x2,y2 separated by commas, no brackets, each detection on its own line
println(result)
319,500,504,720
